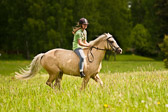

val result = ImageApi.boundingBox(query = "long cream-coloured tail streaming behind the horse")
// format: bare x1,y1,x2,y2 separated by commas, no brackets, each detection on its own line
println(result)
15,53,44,80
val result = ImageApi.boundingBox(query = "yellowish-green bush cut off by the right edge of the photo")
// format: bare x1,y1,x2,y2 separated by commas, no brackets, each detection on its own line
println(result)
159,35,168,68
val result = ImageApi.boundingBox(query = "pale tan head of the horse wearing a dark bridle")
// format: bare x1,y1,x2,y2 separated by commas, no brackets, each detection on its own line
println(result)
105,33,122,54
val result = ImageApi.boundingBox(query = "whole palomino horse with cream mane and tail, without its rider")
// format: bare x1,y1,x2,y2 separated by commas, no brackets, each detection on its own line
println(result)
15,33,122,89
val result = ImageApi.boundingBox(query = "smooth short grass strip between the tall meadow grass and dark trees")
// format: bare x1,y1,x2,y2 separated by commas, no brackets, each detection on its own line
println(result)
0,55,166,75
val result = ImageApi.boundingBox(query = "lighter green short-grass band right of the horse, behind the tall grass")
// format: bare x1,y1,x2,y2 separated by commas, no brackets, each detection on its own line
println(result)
101,61,166,73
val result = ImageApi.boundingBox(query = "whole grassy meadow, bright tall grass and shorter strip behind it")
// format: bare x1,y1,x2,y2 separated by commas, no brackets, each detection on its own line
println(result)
0,55,168,112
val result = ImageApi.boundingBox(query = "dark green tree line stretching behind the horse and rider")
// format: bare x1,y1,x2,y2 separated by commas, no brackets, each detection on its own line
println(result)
0,0,168,58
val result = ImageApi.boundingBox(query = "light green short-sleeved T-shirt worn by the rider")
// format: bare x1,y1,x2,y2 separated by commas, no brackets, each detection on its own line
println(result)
72,29,87,50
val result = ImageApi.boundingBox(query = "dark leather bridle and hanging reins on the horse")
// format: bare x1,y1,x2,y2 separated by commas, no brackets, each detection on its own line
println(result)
87,36,120,63
